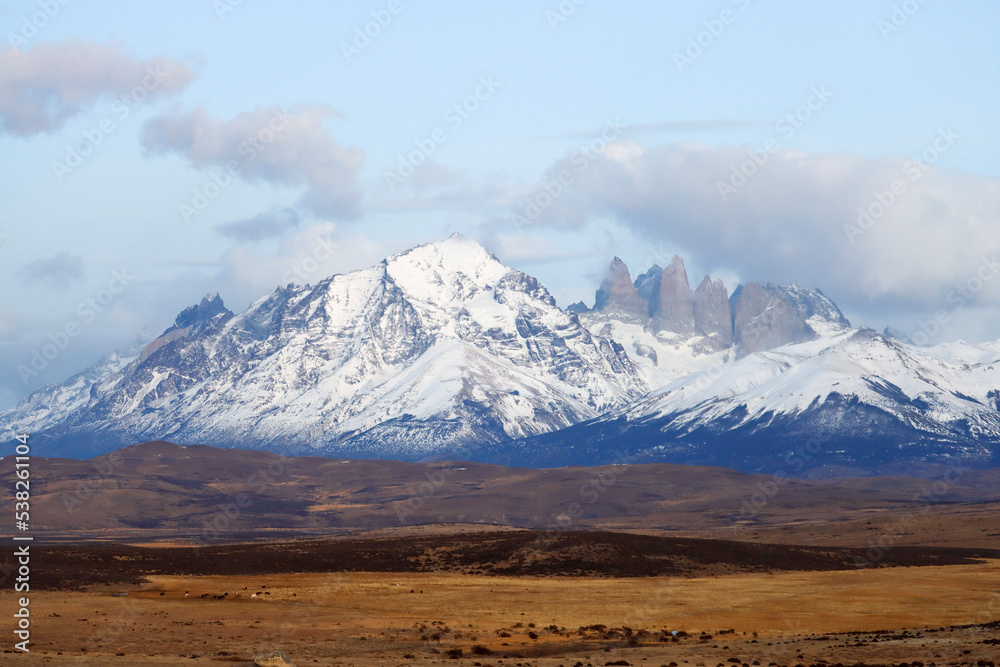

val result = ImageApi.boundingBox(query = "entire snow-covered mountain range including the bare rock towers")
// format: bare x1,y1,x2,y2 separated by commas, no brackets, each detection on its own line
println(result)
0,235,1000,476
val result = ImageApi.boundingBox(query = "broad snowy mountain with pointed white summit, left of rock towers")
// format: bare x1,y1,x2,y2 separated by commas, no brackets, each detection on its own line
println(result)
0,235,649,459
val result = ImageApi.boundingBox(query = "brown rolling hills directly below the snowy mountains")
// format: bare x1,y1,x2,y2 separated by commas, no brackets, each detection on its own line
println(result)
0,442,1000,547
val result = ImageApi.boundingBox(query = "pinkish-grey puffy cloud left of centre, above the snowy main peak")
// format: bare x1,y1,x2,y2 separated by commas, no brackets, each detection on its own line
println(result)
142,106,365,218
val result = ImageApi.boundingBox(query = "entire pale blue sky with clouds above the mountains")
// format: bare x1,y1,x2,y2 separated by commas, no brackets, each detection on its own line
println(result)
0,0,1000,408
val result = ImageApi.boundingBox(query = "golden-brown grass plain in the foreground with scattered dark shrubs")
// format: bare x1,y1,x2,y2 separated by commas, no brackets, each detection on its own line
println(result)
0,561,1000,667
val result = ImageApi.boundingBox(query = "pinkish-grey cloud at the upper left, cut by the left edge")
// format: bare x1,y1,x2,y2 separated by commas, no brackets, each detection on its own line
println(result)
0,41,195,136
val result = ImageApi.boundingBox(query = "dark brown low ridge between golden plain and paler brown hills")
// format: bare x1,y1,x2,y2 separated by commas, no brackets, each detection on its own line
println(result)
25,530,1000,588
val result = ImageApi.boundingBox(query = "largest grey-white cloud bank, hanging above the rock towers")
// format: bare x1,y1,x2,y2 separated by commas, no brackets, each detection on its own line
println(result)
513,137,1000,320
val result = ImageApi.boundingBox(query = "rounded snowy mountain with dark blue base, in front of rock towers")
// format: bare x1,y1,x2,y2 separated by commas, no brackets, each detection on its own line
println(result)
487,329,1000,475
